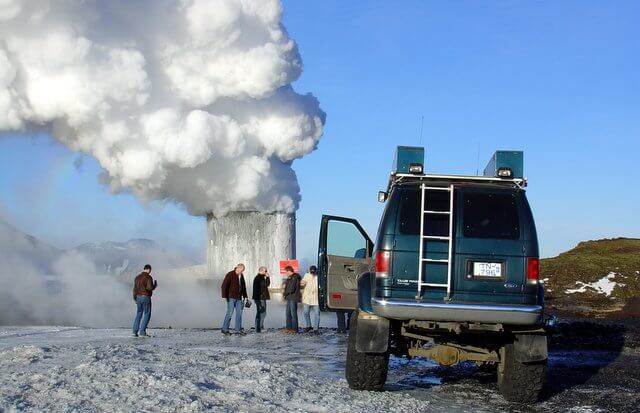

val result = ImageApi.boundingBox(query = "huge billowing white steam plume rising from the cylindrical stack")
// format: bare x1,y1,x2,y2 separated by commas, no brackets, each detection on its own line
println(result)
0,0,325,216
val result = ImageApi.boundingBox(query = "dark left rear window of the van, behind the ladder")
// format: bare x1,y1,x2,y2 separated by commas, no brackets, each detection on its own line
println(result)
400,188,449,236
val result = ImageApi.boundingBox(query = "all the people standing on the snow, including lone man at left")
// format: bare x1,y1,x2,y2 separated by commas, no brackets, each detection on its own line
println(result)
133,264,351,337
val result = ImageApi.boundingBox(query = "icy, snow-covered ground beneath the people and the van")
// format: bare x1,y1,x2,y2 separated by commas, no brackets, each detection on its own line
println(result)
0,327,636,413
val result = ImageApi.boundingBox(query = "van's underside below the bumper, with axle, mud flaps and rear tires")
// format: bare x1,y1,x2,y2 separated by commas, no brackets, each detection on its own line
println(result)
347,310,548,403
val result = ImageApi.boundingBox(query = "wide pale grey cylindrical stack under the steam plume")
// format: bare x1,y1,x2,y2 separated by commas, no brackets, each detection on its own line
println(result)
207,211,296,277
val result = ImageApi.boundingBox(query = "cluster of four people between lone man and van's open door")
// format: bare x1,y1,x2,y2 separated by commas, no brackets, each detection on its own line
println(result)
221,264,320,335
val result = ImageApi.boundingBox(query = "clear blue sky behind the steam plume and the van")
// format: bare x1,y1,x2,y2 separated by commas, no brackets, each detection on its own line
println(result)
0,0,640,260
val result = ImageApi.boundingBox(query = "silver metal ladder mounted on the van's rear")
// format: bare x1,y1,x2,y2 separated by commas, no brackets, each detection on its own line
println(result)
416,184,454,299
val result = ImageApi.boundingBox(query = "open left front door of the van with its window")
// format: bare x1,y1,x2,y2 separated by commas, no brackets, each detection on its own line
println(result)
318,215,373,311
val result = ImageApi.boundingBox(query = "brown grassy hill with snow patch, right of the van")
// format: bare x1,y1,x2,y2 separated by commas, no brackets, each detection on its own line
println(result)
540,238,640,314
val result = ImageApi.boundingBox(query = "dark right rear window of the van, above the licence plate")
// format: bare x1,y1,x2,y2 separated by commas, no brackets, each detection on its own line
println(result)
464,192,520,239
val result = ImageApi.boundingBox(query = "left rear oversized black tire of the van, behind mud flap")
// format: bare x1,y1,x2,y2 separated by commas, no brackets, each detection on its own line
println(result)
346,312,389,391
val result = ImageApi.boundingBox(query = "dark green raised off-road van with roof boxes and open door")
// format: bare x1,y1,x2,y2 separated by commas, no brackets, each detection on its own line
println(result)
318,147,547,402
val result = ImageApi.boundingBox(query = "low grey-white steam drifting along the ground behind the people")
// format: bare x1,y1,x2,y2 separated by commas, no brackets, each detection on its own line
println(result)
0,212,284,329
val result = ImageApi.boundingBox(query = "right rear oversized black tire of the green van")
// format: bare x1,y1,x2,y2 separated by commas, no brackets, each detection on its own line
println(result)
498,343,547,403
